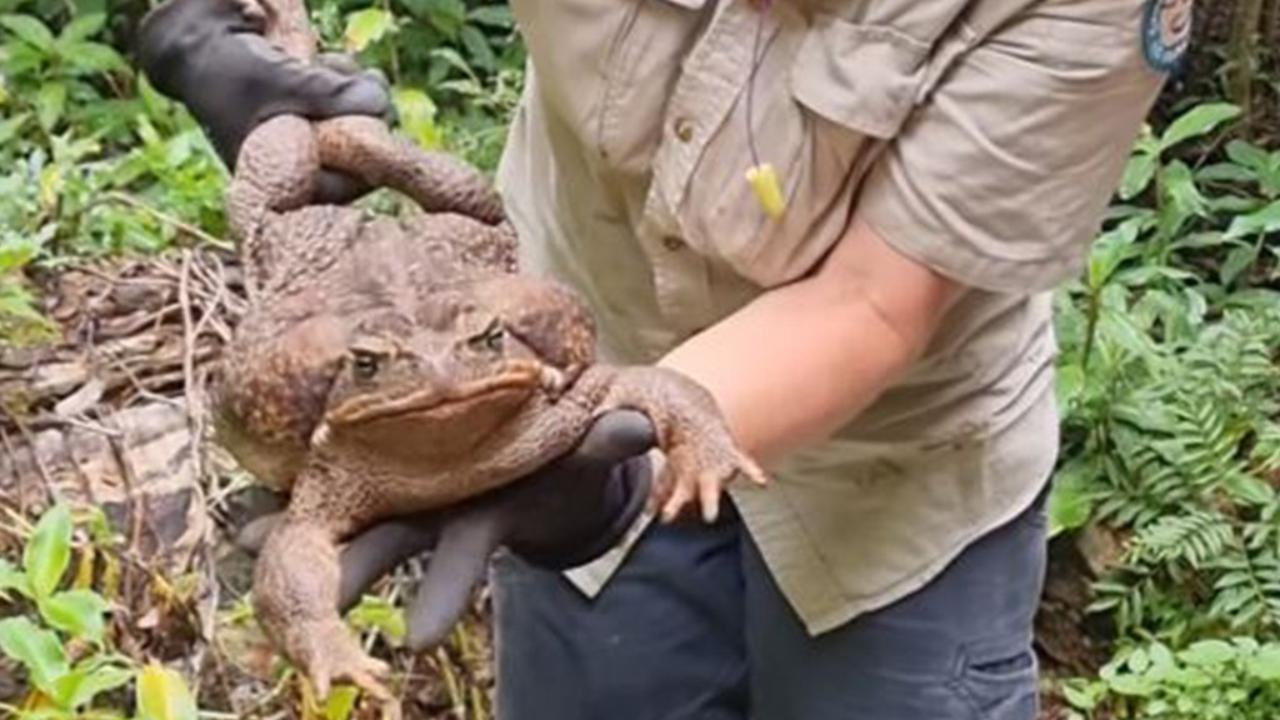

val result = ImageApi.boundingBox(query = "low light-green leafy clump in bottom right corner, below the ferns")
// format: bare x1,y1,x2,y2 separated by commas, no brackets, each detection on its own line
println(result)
1064,638,1280,720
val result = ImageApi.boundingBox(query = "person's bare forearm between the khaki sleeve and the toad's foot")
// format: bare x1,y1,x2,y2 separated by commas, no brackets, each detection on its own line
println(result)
662,219,959,464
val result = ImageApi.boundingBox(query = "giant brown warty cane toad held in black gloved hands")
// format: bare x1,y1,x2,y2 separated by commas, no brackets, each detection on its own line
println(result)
215,0,764,696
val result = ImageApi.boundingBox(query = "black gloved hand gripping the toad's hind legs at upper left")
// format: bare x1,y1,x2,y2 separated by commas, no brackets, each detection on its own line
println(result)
137,0,390,204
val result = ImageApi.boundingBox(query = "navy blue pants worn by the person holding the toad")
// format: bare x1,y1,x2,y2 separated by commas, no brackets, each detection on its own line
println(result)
494,484,1046,720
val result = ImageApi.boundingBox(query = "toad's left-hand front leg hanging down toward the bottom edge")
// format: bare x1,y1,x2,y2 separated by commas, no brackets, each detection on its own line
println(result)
253,471,390,701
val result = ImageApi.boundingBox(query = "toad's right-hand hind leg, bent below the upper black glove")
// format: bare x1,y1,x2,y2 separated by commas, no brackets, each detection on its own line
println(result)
316,115,504,224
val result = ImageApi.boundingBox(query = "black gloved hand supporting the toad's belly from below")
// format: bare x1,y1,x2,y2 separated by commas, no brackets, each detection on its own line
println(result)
238,410,657,650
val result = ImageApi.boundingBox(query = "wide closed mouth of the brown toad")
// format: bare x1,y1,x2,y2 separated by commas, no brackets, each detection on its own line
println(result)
326,364,563,425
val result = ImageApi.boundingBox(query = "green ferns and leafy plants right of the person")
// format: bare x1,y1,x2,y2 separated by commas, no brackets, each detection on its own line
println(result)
1051,96,1280,719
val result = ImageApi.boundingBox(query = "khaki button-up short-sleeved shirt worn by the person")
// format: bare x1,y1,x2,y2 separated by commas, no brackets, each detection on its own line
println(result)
499,0,1164,633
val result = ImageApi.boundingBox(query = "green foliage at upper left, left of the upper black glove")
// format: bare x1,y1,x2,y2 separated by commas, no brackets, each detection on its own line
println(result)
0,13,224,343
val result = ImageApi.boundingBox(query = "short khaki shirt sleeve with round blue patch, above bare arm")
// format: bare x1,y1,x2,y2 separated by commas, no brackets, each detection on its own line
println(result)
856,0,1165,293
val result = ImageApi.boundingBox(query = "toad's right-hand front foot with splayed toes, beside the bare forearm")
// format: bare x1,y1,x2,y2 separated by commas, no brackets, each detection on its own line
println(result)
602,368,768,523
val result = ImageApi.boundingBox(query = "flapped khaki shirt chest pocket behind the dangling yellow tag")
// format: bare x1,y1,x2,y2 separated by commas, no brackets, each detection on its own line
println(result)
657,15,969,287
